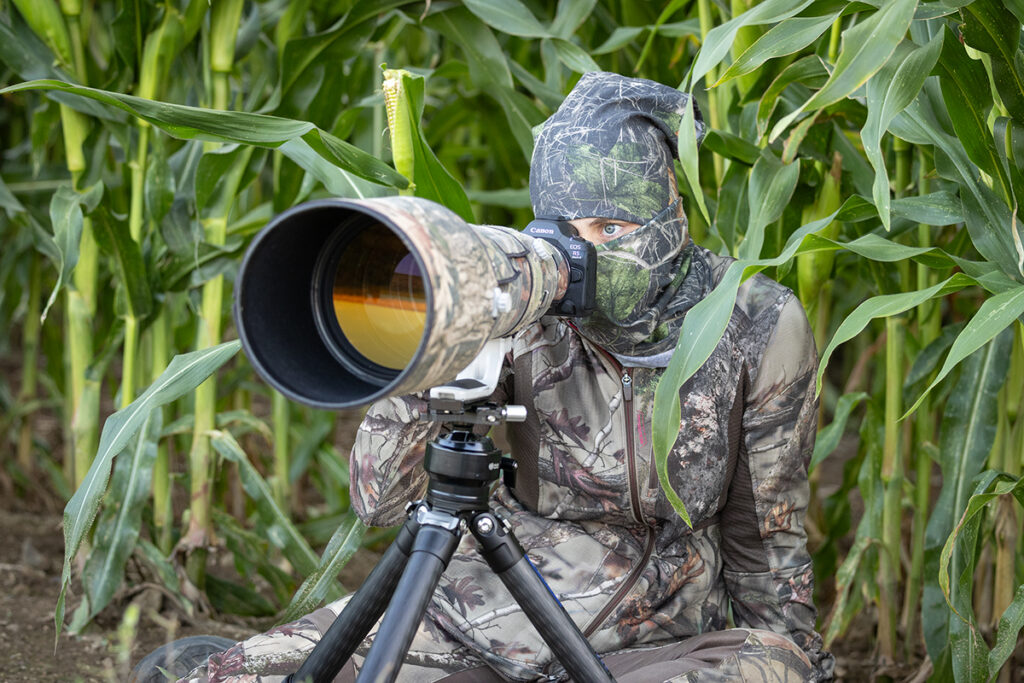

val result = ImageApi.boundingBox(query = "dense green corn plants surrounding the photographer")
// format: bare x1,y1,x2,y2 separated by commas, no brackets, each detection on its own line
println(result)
0,0,1024,681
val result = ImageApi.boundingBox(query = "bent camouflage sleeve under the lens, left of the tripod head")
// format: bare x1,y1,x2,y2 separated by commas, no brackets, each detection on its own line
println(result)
348,361,511,526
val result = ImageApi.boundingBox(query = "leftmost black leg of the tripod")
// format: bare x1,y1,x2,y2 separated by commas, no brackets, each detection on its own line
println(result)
288,515,420,683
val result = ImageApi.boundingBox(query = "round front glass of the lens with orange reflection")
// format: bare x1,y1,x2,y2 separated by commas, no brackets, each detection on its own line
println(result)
333,224,427,370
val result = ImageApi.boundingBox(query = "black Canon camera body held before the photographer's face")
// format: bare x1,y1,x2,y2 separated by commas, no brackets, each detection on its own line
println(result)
522,216,597,317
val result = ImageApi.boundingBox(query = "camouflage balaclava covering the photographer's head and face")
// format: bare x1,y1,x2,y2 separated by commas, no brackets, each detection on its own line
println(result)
529,72,708,365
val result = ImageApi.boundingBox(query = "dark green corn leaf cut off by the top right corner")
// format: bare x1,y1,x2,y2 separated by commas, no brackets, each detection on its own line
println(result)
961,0,1024,123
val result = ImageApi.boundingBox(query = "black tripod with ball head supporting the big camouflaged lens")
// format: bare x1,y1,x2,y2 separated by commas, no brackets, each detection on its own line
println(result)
287,394,614,683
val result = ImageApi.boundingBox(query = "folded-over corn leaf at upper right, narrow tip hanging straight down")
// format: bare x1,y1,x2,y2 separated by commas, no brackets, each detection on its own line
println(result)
860,33,942,230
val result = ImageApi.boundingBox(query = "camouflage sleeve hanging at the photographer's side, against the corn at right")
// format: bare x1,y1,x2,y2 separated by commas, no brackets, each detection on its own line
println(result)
722,296,834,681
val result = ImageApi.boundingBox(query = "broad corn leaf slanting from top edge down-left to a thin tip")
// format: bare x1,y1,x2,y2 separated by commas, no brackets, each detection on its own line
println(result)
770,0,918,140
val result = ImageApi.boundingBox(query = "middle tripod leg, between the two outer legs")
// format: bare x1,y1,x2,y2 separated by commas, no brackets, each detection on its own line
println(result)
356,508,462,683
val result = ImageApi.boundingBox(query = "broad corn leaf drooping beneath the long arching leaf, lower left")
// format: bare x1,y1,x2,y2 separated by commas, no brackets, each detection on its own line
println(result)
82,411,161,621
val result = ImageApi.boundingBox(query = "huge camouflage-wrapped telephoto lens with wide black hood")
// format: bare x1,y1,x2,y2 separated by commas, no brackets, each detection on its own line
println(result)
234,197,569,409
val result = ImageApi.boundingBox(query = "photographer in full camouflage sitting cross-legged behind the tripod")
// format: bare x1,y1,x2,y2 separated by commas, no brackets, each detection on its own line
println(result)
144,73,833,682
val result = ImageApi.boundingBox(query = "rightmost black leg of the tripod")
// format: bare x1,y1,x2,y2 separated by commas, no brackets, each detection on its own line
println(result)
469,512,614,683
